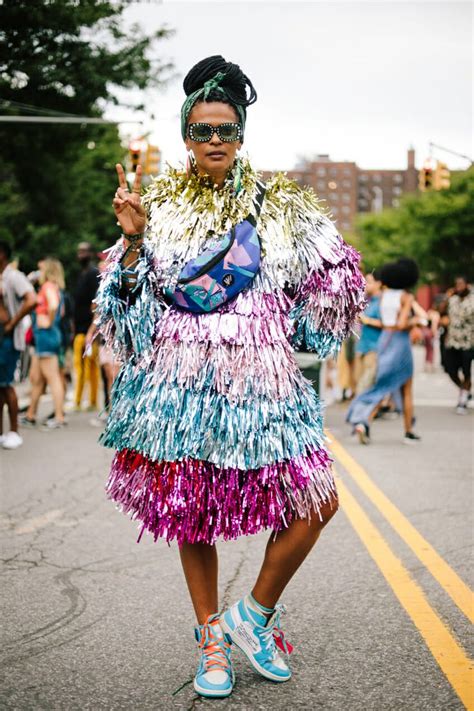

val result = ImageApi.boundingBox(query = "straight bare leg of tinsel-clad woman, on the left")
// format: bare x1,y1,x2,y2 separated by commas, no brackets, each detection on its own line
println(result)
179,543,219,625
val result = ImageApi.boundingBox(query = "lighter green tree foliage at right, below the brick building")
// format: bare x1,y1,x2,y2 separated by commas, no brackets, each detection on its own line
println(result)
355,167,474,285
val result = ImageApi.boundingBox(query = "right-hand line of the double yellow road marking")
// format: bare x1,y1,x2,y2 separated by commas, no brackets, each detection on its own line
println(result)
328,433,474,623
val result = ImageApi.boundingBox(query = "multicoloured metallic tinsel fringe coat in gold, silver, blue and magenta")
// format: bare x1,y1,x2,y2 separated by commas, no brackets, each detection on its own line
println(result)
97,163,365,544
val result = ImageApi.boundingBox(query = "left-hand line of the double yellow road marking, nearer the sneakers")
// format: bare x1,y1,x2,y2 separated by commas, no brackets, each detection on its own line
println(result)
337,479,474,711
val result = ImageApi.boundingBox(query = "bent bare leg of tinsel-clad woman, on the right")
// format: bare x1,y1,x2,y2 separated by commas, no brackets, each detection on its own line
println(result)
252,502,337,609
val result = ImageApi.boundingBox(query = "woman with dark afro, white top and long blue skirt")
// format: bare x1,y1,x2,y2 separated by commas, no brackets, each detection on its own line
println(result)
347,258,426,444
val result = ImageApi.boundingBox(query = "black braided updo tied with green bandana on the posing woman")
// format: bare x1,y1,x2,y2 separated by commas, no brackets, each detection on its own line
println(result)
181,54,257,139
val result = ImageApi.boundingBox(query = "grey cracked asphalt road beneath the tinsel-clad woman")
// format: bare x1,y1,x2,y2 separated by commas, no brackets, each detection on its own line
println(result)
0,352,473,711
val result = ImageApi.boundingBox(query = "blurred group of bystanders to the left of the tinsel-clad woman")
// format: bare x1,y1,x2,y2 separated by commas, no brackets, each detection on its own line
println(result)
0,242,117,449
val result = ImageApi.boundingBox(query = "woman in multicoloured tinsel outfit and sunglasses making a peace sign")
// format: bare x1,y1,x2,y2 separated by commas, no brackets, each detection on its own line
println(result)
97,56,364,697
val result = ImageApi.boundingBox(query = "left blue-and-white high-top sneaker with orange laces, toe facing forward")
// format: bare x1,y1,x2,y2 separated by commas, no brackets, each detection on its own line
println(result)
194,615,234,698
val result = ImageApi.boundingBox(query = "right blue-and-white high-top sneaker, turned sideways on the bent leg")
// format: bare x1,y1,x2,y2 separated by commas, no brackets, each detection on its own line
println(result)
221,596,291,682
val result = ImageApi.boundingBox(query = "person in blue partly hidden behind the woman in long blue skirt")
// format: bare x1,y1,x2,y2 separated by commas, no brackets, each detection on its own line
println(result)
355,271,382,395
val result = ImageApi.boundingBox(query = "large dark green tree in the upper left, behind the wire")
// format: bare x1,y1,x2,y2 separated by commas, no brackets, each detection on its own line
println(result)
0,0,171,284
